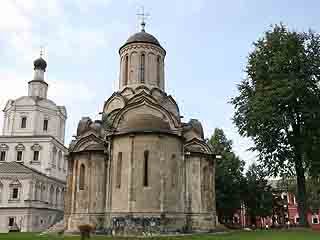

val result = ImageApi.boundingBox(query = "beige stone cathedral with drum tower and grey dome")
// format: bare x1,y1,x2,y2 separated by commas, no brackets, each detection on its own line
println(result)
64,23,216,234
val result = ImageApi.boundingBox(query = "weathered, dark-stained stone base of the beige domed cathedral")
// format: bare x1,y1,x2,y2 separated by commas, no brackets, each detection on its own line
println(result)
65,212,215,235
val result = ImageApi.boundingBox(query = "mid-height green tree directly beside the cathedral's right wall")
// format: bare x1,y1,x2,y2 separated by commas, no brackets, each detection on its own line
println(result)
209,128,244,223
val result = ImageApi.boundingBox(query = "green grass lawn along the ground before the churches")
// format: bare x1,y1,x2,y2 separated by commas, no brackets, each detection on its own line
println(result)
0,230,320,240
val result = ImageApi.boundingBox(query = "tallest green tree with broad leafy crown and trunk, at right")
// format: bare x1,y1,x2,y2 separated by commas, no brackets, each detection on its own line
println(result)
231,24,320,226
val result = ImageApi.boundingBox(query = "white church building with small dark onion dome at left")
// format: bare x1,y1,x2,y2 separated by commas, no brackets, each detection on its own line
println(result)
0,57,67,232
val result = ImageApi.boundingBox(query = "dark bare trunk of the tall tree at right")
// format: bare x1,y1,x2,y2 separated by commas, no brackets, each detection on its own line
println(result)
295,154,308,227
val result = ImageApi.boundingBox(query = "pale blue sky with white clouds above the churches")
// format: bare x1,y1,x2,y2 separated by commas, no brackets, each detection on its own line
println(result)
0,0,320,167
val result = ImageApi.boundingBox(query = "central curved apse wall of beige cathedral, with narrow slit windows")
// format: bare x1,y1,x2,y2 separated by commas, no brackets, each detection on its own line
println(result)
111,134,184,213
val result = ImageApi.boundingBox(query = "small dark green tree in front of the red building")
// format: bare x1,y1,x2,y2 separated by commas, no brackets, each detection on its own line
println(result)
244,163,273,226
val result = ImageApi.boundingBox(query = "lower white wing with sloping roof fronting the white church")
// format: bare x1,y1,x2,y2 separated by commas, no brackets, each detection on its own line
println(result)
0,163,65,232
